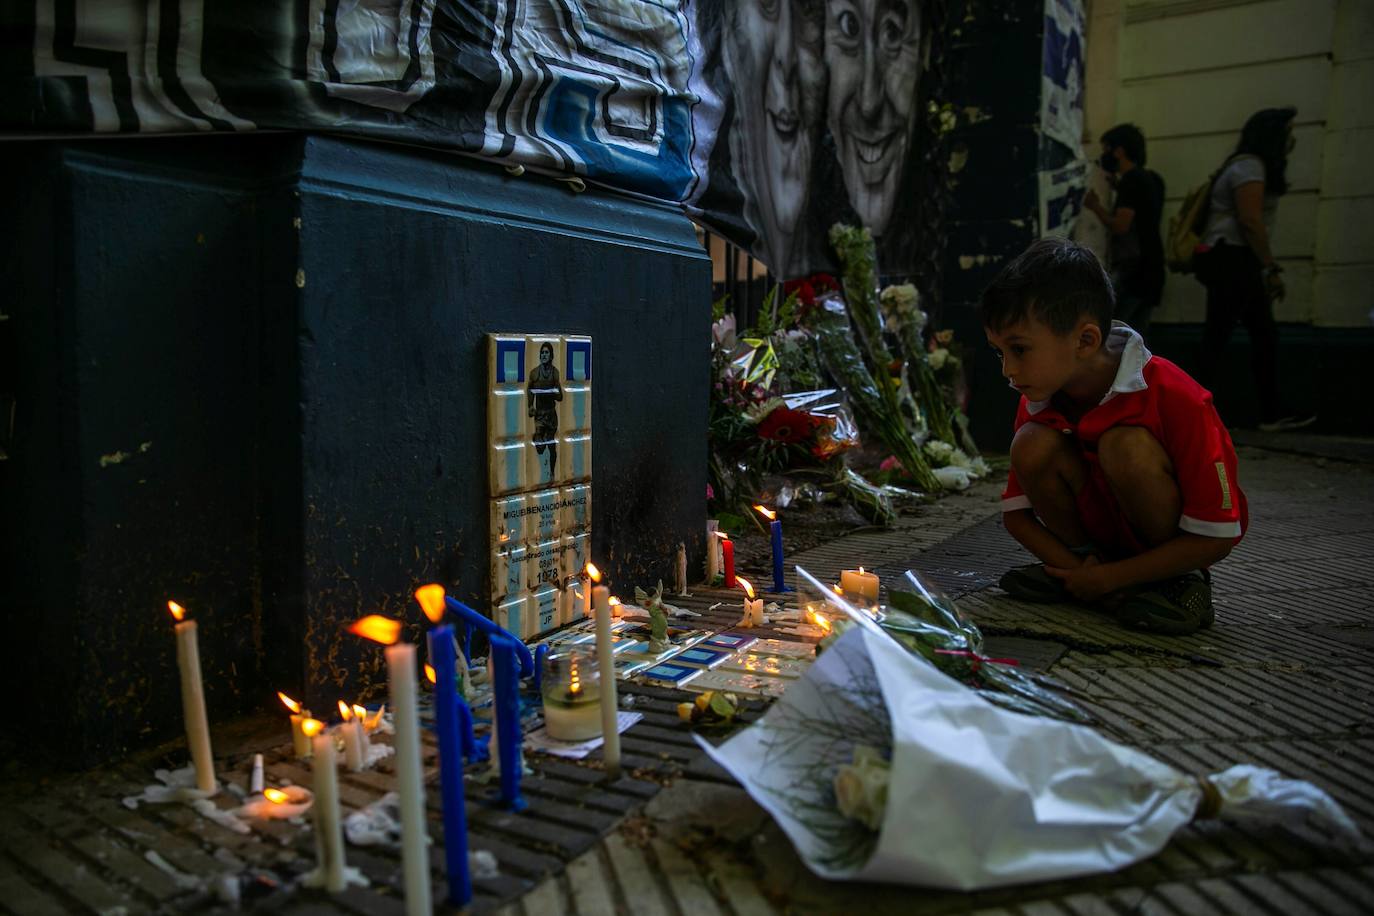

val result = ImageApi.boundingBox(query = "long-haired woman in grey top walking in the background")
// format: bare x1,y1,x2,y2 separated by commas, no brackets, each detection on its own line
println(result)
1197,108,1316,431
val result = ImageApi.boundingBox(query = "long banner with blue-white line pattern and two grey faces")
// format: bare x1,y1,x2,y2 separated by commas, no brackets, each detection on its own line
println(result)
0,0,939,277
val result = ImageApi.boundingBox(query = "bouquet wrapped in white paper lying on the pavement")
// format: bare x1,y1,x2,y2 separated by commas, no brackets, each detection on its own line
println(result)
702,569,1359,890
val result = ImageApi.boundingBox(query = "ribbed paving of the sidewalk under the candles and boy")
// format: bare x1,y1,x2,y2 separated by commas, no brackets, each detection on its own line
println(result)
0,449,1374,916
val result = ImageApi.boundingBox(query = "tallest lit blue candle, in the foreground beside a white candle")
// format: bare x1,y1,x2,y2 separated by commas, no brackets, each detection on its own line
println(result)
430,623,473,906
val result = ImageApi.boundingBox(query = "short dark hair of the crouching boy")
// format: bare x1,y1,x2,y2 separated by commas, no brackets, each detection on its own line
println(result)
978,239,1116,335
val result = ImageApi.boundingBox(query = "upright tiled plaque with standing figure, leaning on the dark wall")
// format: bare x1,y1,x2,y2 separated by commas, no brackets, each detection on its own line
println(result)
486,334,592,639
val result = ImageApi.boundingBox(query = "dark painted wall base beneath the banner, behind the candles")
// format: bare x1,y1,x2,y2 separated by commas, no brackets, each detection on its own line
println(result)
0,135,709,764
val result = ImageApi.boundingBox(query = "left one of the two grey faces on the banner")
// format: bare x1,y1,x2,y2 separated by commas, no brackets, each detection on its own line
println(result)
721,0,824,275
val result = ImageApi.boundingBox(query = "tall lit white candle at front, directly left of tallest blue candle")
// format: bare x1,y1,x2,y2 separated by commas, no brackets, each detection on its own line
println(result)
386,643,434,916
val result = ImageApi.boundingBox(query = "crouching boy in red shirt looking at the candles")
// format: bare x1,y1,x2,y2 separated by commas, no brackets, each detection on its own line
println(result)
981,239,1249,634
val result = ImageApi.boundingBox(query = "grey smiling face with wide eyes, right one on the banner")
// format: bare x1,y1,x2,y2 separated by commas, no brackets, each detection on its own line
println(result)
824,0,921,235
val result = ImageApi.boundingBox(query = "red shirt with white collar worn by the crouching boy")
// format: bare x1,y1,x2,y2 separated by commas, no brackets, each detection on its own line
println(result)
1002,321,1250,540
